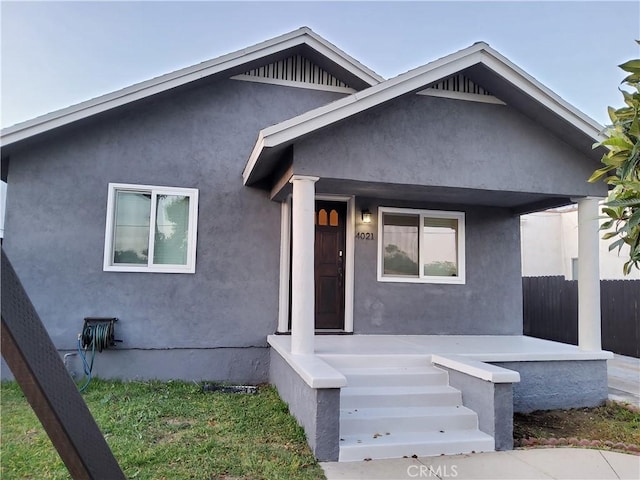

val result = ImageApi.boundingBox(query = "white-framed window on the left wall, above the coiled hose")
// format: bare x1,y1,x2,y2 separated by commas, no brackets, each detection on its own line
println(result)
104,183,198,273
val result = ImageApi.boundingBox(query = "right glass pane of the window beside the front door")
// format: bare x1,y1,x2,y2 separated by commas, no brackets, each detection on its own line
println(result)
423,217,458,277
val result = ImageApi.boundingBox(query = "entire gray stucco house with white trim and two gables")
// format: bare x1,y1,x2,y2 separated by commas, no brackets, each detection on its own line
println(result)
2,28,611,461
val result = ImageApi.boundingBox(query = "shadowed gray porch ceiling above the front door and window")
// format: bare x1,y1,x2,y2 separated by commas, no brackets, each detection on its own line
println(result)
271,178,573,214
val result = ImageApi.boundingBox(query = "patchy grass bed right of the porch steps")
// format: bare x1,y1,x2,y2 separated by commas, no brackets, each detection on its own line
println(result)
513,401,640,446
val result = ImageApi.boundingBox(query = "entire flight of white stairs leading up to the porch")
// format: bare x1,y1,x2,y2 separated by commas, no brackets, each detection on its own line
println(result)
323,355,495,462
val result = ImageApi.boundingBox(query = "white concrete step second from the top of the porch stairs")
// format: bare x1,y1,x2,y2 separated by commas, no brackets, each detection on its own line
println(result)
340,366,448,387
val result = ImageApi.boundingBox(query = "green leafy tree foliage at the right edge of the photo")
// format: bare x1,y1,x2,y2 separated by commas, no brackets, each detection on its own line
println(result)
589,41,640,275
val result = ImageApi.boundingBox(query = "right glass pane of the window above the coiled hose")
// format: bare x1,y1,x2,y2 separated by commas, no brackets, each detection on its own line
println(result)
153,195,189,265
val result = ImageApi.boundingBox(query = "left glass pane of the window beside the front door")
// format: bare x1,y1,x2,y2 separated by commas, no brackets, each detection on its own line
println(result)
382,213,420,277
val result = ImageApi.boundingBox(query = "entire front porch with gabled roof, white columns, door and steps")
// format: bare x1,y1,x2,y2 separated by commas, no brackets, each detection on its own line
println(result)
243,44,610,461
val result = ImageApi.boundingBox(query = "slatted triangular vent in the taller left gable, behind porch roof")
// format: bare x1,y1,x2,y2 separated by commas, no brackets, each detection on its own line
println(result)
232,55,355,93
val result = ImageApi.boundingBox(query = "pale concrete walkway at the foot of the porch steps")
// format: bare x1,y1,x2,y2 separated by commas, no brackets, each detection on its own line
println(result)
321,448,640,480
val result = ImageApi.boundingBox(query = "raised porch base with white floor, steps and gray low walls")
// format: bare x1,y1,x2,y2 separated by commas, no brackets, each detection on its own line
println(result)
268,335,612,461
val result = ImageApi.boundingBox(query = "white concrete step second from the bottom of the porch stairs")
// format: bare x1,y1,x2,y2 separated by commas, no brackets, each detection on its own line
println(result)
340,405,478,435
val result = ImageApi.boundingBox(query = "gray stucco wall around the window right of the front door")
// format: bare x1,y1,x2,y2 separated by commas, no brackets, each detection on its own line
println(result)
354,198,522,335
